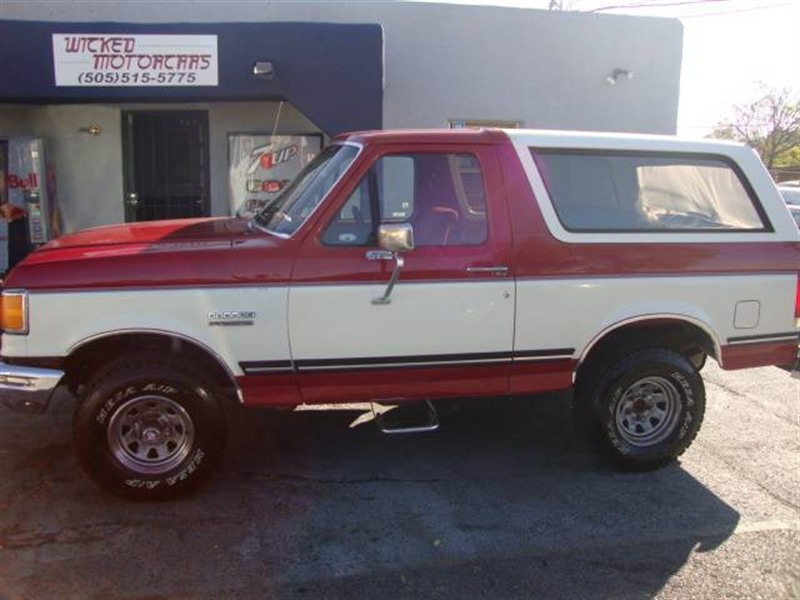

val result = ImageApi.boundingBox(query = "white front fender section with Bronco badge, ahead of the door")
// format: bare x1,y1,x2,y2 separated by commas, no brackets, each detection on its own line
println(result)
16,287,289,375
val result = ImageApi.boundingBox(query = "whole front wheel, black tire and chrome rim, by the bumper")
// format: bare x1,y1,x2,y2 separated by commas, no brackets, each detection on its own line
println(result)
73,355,225,500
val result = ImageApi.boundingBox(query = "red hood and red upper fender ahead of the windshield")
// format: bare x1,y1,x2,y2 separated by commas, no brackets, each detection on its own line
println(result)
4,217,297,291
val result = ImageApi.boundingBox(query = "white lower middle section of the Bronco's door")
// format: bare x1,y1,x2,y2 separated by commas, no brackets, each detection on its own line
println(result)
289,276,514,360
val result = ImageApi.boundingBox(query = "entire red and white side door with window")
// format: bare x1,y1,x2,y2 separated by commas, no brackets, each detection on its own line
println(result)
288,145,515,402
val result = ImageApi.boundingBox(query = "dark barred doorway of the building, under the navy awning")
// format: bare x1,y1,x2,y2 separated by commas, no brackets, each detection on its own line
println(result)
122,110,210,222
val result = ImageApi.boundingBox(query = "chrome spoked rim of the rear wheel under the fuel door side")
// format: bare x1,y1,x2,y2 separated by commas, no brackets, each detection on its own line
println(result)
616,377,681,447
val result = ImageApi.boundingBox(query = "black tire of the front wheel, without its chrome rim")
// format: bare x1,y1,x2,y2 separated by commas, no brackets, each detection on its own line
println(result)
73,357,225,500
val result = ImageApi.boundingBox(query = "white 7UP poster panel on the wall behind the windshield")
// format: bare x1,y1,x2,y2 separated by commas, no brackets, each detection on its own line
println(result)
228,133,322,218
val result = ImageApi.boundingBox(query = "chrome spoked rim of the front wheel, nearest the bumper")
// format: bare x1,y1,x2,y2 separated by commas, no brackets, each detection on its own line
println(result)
107,396,195,475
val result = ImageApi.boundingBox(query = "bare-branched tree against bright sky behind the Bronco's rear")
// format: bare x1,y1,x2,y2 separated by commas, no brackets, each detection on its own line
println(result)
709,86,800,169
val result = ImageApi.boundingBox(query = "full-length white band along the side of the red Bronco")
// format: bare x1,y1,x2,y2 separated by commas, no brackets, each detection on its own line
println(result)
3,274,796,375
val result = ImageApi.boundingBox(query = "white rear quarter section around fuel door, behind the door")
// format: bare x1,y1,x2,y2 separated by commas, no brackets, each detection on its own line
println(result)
514,274,797,358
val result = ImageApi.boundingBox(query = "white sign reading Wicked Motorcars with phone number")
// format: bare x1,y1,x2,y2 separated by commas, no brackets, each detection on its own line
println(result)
53,33,218,87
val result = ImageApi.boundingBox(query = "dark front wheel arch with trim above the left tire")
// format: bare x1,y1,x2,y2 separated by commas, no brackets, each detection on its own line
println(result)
65,329,244,404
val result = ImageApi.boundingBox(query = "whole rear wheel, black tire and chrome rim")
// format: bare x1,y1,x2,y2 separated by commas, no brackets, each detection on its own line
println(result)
575,348,705,470
